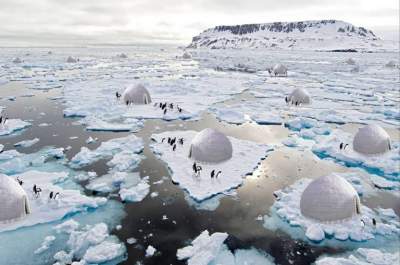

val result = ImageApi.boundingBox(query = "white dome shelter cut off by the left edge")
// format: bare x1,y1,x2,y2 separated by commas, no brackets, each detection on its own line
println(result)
0,174,30,223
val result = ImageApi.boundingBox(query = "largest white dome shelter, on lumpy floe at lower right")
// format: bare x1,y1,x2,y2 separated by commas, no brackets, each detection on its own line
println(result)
300,174,361,222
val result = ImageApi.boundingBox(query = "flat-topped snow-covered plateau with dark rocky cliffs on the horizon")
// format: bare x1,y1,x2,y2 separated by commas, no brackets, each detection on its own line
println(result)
188,20,398,52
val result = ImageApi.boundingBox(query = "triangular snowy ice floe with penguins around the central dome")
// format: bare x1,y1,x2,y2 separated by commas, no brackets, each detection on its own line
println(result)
151,131,272,202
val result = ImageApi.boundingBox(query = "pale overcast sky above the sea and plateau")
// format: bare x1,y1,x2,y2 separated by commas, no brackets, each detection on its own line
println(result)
0,0,399,46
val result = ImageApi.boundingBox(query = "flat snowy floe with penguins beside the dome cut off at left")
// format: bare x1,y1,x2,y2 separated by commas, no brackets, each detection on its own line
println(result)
0,171,107,232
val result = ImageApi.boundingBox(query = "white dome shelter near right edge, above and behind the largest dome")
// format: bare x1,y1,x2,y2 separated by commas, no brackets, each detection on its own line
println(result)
353,124,391,155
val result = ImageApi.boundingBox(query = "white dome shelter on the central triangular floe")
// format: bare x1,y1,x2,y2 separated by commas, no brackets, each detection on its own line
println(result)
189,128,232,163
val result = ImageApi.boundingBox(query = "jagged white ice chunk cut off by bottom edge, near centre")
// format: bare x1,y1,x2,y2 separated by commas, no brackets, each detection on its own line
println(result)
176,230,228,265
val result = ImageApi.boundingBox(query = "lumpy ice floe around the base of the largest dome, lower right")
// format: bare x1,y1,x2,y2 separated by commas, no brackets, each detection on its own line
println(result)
264,174,400,244
